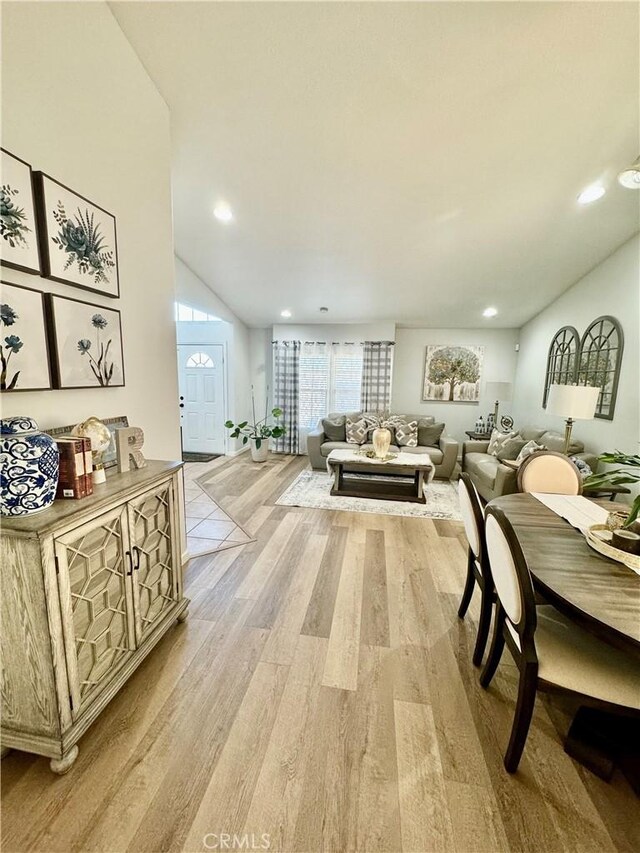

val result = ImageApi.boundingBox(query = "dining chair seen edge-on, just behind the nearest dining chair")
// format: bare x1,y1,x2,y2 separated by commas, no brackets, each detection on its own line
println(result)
458,474,496,666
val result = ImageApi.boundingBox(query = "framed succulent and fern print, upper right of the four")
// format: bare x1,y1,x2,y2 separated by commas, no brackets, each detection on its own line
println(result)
34,172,120,298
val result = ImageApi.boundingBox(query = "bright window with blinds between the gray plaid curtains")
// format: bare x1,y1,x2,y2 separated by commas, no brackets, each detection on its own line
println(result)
299,343,362,430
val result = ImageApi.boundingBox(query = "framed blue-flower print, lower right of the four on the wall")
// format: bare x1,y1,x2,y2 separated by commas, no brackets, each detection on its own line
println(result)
47,293,124,388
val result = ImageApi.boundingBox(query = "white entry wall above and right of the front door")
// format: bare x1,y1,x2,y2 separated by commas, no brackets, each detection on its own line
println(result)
175,256,255,451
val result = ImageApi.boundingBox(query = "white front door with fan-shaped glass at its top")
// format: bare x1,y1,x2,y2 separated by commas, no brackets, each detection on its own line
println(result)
178,344,226,454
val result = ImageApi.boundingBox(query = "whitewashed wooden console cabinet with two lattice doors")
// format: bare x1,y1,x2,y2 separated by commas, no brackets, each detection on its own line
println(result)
0,461,189,773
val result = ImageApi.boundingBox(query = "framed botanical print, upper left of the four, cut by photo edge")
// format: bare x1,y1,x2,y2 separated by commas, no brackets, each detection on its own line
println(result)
0,148,41,275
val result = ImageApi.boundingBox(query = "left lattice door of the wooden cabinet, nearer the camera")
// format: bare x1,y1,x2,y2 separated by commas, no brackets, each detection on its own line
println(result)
55,506,136,718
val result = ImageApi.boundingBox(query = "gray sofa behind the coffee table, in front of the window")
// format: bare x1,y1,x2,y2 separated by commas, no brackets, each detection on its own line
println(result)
307,412,458,480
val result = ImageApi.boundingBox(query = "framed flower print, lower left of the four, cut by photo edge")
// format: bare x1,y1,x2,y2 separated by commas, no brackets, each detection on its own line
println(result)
0,281,52,391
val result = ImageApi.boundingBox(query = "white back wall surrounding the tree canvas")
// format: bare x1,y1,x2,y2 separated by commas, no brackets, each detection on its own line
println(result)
391,327,518,441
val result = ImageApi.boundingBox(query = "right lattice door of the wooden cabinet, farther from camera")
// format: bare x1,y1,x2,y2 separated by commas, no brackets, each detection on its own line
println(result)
129,482,181,642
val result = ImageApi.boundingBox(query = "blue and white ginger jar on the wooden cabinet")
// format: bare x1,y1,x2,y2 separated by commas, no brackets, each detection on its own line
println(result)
0,417,59,516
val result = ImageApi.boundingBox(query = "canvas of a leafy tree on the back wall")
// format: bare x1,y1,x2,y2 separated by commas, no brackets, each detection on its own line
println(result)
422,345,484,403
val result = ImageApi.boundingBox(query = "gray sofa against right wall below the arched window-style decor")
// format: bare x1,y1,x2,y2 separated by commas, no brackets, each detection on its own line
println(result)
462,426,597,501
